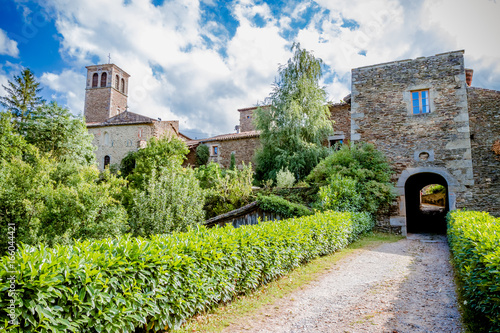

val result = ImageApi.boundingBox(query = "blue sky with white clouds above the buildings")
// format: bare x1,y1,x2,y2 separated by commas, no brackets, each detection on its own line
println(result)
0,0,500,139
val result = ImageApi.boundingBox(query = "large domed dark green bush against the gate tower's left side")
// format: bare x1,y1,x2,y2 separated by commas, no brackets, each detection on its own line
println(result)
307,142,394,213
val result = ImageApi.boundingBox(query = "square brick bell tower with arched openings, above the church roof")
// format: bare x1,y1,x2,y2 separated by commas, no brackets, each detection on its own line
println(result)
84,64,130,123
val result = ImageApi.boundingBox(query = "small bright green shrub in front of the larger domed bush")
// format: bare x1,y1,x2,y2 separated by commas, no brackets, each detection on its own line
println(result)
319,174,362,212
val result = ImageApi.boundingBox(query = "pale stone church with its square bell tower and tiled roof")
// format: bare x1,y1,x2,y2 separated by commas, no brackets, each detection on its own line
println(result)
84,64,184,170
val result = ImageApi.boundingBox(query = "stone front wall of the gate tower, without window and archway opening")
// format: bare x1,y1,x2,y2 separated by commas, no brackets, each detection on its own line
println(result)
351,51,474,233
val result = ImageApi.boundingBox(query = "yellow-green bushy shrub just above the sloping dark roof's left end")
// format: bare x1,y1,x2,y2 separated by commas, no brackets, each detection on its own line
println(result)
195,162,253,218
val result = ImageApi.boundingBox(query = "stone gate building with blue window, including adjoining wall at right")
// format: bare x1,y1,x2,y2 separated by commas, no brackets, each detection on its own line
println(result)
351,51,500,234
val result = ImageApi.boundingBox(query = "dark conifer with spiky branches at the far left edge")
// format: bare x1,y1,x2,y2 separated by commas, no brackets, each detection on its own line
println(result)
0,68,45,126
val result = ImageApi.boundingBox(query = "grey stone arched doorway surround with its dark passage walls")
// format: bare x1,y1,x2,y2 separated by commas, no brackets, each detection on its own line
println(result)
390,167,459,236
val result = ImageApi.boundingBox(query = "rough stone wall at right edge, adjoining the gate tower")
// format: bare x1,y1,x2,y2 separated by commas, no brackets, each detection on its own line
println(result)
467,88,500,216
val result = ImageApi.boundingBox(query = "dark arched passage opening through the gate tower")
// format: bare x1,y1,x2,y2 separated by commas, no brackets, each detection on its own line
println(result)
405,172,450,234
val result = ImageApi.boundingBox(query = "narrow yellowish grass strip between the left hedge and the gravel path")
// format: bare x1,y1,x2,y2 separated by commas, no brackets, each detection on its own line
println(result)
175,232,403,333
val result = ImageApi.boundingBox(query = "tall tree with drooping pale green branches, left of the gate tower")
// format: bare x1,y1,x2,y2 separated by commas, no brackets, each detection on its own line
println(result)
254,44,332,180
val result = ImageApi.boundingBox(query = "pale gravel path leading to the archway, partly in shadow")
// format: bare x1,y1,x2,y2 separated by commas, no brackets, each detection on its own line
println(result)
224,235,463,333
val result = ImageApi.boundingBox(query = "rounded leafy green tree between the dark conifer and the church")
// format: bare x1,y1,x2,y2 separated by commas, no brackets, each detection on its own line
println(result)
24,102,95,165
